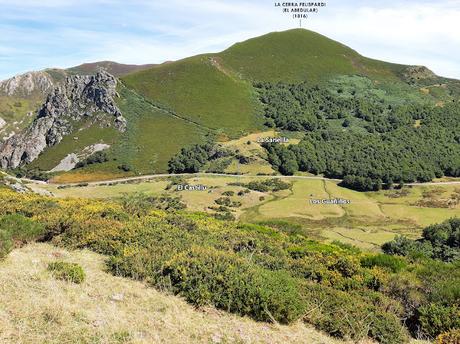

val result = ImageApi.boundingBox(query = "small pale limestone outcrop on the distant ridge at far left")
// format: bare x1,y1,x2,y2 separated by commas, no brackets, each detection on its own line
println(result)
0,71,54,97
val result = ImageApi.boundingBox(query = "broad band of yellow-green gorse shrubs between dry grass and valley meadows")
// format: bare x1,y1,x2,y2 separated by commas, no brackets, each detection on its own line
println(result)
0,190,460,343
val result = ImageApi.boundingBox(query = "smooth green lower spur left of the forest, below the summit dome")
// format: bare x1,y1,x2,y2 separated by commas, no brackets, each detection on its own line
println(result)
122,55,261,136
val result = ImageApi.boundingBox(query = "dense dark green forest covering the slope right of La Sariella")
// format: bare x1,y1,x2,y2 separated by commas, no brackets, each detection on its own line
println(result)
256,84,460,191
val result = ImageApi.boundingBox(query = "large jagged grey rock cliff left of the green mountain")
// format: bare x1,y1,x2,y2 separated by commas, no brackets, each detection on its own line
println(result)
0,72,126,169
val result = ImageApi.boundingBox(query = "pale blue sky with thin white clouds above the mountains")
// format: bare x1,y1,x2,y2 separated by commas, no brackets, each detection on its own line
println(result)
0,0,460,80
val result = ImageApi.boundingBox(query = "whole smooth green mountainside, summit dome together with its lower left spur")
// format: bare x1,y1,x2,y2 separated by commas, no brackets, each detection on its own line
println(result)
118,29,414,142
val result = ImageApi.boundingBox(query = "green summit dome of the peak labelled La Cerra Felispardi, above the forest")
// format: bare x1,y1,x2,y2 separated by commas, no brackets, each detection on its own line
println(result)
219,29,404,82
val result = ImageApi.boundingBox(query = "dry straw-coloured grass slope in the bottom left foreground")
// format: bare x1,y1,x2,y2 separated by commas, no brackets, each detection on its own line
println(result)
0,244,342,344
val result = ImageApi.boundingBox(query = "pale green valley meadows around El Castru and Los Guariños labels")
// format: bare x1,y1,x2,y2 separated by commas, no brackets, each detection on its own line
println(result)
29,174,460,251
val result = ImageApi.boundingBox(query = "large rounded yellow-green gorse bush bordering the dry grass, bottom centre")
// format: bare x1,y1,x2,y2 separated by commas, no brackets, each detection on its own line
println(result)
163,248,305,323
